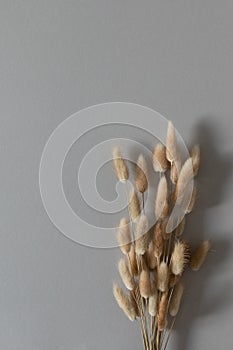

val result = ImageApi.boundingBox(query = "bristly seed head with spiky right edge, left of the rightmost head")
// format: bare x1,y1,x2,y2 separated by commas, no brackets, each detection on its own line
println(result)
171,241,189,275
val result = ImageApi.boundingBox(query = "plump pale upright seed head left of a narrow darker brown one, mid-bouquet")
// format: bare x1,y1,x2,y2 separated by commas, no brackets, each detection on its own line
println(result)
135,214,149,255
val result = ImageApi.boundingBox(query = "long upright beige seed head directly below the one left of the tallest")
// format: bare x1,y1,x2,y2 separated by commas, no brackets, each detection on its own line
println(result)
155,176,169,219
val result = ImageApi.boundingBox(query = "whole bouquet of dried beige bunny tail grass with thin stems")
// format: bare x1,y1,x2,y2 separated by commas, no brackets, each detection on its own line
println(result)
113,122,210,350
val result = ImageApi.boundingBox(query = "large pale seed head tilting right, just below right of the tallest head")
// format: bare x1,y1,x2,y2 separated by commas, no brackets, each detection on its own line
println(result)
175,158,194,204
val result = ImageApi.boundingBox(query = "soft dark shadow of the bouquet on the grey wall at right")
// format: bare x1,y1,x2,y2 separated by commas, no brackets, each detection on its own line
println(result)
172,118,233,350
